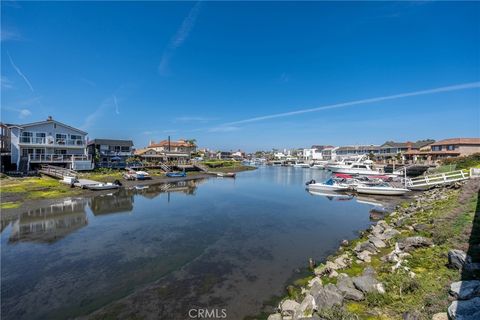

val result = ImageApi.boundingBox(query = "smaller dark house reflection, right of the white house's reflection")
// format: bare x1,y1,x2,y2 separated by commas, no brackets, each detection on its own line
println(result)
90,190,134,216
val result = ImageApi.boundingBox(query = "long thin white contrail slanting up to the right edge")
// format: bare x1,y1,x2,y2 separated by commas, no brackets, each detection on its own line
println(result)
221,82,480,126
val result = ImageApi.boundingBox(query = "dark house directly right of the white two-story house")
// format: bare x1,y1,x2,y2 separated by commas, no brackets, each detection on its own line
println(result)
87,139,133,168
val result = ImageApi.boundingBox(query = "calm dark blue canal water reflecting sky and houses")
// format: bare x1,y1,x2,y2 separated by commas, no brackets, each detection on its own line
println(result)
1,167,390,320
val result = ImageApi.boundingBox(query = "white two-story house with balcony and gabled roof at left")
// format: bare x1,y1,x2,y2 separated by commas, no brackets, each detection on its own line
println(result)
10,117,93,171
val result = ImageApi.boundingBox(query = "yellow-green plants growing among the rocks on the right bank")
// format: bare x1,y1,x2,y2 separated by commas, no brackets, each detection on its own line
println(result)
255,180,480,320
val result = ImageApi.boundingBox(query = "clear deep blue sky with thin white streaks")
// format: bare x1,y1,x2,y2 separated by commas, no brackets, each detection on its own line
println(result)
1,2,480,151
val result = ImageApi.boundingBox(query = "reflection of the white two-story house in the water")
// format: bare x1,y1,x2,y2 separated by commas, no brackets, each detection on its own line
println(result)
9,200,88,243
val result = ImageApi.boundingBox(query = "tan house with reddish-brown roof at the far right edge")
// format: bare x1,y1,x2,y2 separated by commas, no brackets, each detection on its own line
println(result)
405,138,480,163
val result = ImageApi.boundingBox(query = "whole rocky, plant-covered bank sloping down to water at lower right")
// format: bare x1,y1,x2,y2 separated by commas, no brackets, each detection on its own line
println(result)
264,179,480,320
